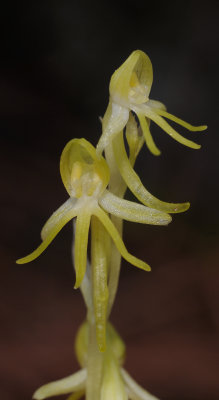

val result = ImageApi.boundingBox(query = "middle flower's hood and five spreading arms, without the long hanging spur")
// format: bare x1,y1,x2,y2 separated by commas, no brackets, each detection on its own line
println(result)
17,139,171,288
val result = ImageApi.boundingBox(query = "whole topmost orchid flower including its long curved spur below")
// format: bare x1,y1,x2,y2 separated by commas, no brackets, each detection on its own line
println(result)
97,50,207,213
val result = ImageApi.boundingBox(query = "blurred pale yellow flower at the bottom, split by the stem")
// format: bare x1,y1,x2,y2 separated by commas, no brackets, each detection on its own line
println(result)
33,322,159,400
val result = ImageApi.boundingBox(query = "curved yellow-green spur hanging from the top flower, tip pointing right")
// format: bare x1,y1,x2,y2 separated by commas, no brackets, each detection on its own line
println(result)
113,133,189,213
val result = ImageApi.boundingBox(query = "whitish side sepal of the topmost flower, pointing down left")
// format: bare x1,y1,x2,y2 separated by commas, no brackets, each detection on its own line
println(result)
97,101,129,155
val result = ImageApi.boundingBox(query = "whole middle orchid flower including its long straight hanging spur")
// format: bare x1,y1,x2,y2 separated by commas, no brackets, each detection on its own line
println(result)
17,139,171,351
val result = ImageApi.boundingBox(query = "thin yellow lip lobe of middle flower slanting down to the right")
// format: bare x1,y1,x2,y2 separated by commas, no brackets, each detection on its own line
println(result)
94,207,151,271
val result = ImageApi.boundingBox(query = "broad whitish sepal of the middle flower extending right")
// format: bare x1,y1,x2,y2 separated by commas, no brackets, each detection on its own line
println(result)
99,190,172,225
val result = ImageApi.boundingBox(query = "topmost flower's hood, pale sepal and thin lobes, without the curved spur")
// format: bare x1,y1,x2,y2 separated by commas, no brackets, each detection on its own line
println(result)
97,50,207,155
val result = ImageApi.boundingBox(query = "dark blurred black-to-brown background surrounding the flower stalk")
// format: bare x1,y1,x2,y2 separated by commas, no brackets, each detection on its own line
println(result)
0,0,219,400
